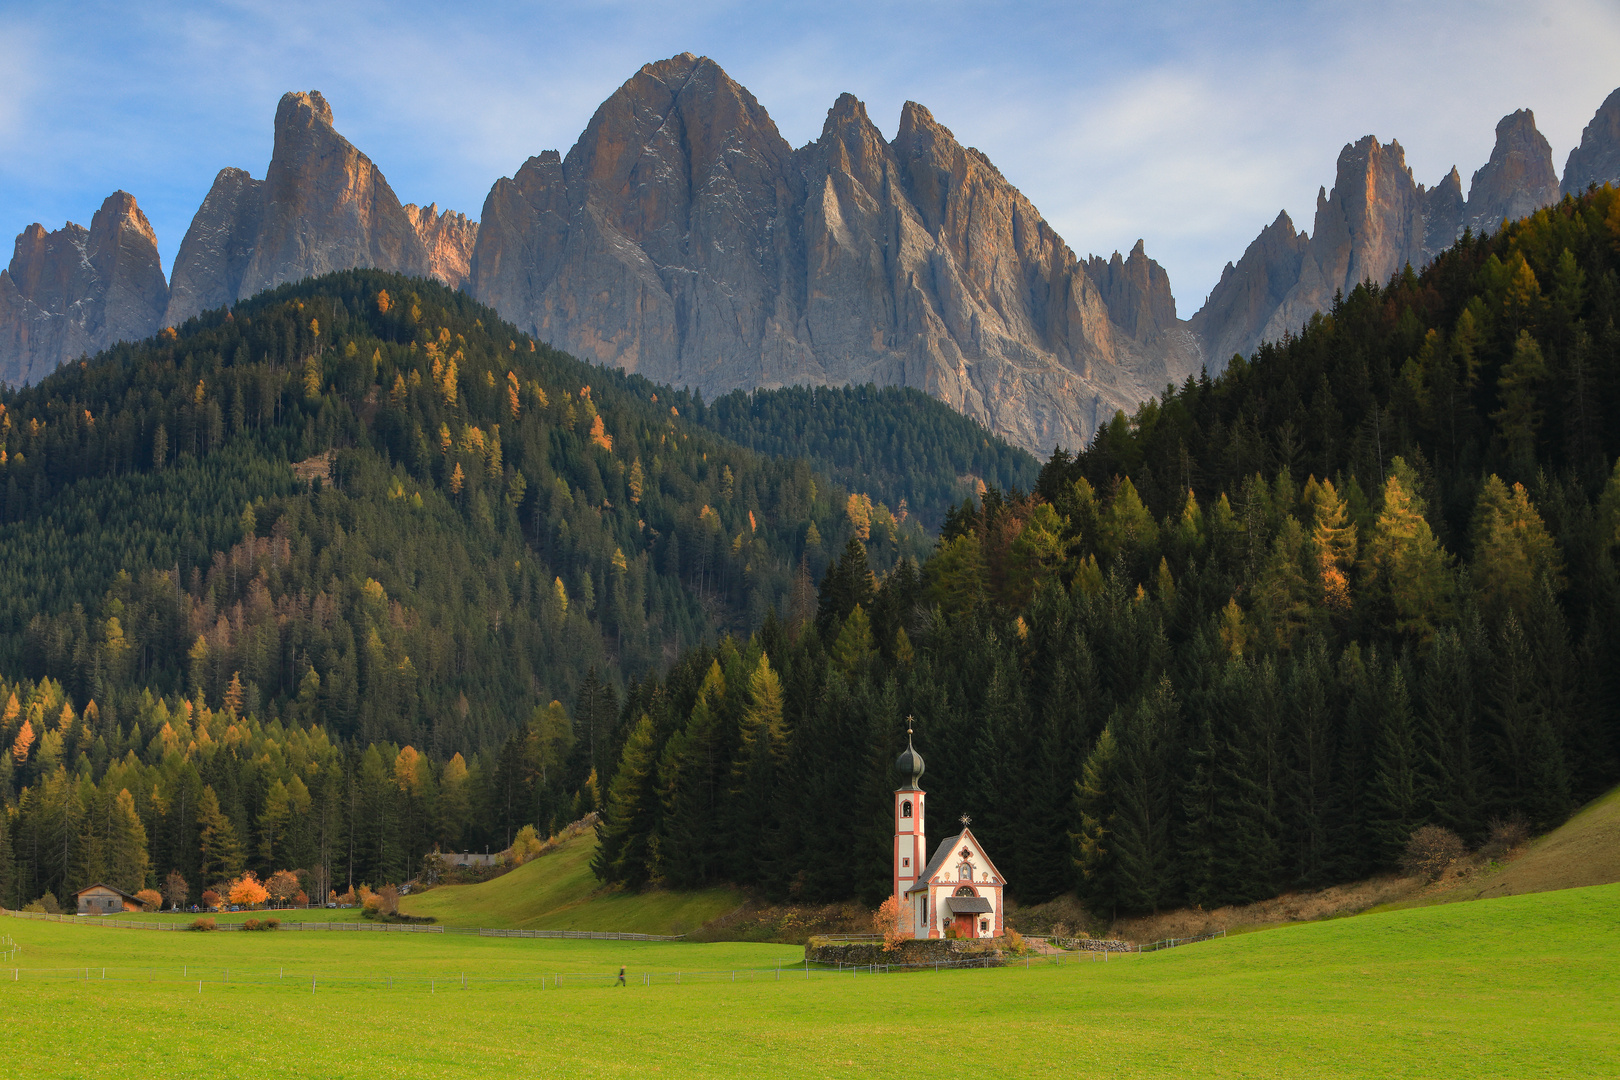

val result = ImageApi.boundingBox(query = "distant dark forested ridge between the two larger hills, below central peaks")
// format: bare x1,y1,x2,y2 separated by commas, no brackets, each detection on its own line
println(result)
690,384,1040,531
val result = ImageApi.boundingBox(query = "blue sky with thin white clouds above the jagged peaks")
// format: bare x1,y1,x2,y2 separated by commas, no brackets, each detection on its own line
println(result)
0,0,1620,317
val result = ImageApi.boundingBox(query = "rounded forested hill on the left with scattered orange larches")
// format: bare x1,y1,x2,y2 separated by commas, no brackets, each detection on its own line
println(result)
0,272,959,905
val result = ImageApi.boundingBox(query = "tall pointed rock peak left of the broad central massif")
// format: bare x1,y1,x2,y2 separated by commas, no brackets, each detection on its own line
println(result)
167,91,478,324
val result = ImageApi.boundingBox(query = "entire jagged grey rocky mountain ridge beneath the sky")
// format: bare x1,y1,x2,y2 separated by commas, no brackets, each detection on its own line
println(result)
0,63,1620,453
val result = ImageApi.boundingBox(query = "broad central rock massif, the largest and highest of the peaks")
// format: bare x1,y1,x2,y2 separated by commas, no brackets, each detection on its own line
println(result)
468,53,1199,453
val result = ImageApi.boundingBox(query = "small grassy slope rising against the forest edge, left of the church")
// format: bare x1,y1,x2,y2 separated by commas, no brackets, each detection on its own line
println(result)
400,834,742,934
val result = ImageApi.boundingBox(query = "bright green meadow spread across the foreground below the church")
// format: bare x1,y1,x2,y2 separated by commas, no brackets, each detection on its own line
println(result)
0,886,1620,1078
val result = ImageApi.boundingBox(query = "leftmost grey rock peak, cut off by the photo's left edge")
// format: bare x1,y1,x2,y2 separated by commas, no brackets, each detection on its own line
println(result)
0,191,168,385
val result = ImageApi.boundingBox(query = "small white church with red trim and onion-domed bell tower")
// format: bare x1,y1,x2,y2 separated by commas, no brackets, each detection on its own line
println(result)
894,724,1006,938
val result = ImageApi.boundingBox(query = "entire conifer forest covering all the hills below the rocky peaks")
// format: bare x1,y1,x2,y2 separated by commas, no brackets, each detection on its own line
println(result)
0,188,1620,913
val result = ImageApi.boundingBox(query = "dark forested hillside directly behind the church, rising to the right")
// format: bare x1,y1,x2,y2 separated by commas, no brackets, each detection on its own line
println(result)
598,188,1620,913
